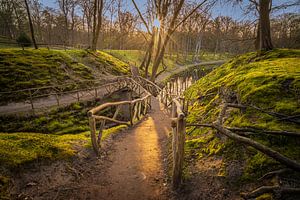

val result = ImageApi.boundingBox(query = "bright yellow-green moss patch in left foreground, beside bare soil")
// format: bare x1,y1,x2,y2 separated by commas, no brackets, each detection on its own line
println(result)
0,133,89,168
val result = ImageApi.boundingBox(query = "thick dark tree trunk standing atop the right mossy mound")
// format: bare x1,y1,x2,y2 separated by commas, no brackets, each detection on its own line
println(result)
259,0,273,51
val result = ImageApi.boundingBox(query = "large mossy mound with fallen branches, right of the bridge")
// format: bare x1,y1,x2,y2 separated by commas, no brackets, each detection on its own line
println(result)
185,49,300,180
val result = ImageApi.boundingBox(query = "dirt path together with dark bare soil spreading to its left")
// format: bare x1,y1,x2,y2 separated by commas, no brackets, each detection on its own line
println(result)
12,99,172,200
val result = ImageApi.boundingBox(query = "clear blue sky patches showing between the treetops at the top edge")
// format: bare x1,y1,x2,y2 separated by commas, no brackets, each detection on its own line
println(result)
40,0,300,20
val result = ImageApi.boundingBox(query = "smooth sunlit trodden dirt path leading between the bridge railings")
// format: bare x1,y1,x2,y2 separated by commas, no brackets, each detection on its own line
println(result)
104,97,170,200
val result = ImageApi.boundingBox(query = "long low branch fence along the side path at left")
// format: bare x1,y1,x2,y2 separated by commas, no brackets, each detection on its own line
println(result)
0,76,145,114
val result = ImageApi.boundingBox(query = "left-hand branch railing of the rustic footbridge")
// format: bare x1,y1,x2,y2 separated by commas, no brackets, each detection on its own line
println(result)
88,77,152,155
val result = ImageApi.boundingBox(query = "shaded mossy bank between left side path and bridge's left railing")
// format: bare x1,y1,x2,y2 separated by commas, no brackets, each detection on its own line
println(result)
0,101,113,135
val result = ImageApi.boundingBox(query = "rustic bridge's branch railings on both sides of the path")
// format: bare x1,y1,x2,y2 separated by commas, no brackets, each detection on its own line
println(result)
88,76,192,188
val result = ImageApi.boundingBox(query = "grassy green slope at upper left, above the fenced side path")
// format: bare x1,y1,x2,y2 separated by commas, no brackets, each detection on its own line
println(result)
0,48,129,102
